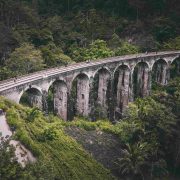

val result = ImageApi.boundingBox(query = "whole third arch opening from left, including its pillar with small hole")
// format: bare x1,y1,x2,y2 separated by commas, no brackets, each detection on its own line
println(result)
69,73,90,119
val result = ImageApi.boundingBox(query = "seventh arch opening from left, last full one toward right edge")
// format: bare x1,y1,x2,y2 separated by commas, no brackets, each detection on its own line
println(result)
152,59,168,85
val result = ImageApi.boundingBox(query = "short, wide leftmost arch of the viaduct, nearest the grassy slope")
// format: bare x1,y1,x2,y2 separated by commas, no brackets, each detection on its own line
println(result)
18,85,43,110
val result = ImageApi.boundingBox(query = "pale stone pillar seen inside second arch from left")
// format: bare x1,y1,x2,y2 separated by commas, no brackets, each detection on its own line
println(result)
54,82,67,120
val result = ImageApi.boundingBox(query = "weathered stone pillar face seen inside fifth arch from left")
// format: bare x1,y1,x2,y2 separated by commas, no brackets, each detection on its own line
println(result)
117,69,130,113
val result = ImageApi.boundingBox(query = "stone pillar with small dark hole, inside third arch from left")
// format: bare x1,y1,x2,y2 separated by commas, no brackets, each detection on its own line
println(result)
76,76,90,116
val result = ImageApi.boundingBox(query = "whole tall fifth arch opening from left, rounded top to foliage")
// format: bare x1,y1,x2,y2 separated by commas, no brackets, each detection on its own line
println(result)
114,65,131,119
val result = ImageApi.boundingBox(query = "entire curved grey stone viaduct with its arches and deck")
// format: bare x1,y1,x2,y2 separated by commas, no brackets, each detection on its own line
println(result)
0,51,180,120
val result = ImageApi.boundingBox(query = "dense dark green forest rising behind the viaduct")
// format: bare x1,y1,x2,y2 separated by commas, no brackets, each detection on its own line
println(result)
0,0,180,80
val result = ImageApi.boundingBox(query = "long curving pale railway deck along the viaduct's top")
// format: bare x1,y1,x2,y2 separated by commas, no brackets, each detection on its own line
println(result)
0,51,180,92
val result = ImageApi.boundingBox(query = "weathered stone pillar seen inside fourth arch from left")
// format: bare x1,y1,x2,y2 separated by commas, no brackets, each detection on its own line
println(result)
98,71,110,112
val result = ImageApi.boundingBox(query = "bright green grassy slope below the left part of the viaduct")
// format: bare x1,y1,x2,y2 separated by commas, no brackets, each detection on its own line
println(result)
0,97,114,180
